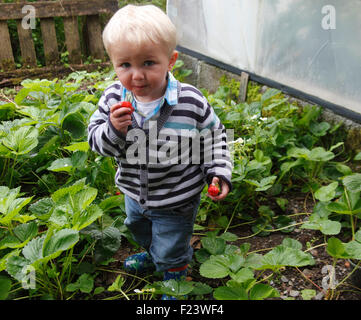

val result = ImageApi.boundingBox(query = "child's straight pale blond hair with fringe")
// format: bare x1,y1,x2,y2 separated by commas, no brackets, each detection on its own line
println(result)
103,5,177,55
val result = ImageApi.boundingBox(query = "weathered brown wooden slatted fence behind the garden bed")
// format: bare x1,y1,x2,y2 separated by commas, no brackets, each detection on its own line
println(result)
0,0,118,84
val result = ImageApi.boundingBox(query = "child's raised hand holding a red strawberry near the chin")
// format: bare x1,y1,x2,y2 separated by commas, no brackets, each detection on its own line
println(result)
109,101,134,135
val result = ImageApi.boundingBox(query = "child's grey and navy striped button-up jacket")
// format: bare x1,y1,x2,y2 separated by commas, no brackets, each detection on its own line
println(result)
88,73,232,209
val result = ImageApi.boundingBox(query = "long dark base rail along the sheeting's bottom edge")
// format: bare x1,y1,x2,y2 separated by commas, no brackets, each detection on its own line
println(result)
177,45,361,124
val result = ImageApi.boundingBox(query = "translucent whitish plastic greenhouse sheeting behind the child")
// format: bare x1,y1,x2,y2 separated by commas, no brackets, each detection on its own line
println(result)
167,0,361,114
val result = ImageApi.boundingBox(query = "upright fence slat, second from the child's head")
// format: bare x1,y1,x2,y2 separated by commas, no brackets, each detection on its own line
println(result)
63,17,81,63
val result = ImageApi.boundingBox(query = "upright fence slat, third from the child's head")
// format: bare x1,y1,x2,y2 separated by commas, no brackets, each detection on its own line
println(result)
40,18,59,66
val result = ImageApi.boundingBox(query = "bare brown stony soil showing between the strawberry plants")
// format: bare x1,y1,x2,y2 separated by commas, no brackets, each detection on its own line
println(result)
109,196,361,300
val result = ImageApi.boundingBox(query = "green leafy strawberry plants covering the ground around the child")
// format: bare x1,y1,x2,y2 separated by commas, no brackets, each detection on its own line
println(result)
0,63,361,300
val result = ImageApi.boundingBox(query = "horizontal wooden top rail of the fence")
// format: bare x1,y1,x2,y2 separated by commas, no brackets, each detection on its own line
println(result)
0,0,118,20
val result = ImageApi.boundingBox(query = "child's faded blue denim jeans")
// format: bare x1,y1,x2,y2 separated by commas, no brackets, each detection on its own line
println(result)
124,195,200,271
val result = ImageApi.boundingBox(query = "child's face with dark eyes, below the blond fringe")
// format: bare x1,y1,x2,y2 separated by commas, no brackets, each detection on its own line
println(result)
110,43,178,102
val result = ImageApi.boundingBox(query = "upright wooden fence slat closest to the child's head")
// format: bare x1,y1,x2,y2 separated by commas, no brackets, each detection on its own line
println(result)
86,15,105,60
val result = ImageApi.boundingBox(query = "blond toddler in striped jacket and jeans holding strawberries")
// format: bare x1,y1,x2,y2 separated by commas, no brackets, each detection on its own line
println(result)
88,5,232,299
